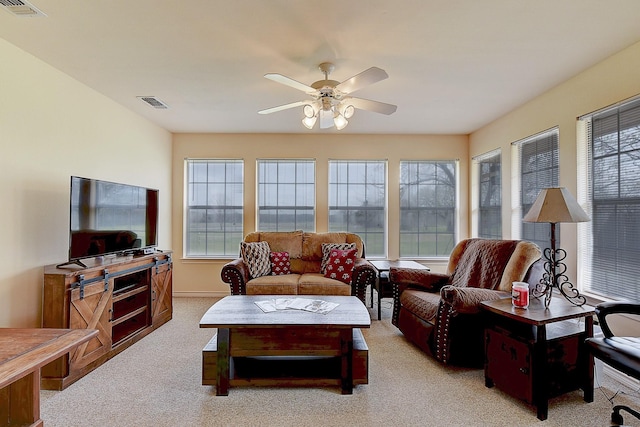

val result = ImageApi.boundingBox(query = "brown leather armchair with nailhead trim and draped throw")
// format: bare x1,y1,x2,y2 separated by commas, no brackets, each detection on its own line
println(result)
389,239,544,367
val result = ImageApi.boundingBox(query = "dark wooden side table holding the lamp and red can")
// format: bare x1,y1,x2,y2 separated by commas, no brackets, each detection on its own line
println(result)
481,295,595,420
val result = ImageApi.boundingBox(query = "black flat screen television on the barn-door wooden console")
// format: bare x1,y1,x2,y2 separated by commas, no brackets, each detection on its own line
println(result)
60,176,158,266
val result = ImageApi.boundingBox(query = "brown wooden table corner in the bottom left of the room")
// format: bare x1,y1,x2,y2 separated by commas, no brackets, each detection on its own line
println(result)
0,328,98,427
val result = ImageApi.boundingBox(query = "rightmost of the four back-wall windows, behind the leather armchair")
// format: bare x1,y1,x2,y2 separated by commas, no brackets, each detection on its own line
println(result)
400,161,458,258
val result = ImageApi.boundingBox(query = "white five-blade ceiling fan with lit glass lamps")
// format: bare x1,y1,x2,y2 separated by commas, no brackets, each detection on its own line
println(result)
258,62,398,130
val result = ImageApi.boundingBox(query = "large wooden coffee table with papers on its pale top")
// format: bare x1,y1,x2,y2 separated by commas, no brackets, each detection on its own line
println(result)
200,295,371,396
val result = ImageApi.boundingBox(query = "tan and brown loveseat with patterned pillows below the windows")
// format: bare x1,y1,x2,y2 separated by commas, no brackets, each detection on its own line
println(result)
221,231,377,303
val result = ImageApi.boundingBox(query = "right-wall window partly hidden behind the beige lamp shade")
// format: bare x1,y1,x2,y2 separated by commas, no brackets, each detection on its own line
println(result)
514,128,560,250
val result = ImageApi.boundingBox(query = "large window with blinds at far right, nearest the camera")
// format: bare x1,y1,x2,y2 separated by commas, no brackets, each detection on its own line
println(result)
578,99,640,302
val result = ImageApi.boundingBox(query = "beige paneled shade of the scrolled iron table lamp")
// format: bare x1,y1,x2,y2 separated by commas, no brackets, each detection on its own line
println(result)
522,187,590,223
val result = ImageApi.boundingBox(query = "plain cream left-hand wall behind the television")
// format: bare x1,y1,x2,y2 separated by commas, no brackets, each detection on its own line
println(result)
0,39,171,327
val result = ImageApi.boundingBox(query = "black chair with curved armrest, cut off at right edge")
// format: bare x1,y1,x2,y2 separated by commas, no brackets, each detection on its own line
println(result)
586,301,640,425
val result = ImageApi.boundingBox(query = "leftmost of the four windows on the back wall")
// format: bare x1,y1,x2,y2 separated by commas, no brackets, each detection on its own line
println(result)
185,160,244,257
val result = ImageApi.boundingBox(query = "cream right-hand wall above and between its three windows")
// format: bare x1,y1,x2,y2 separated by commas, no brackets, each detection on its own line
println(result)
469,39,640,333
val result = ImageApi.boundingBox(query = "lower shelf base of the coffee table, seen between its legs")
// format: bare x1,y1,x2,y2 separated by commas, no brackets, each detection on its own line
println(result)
202,328,369,387
